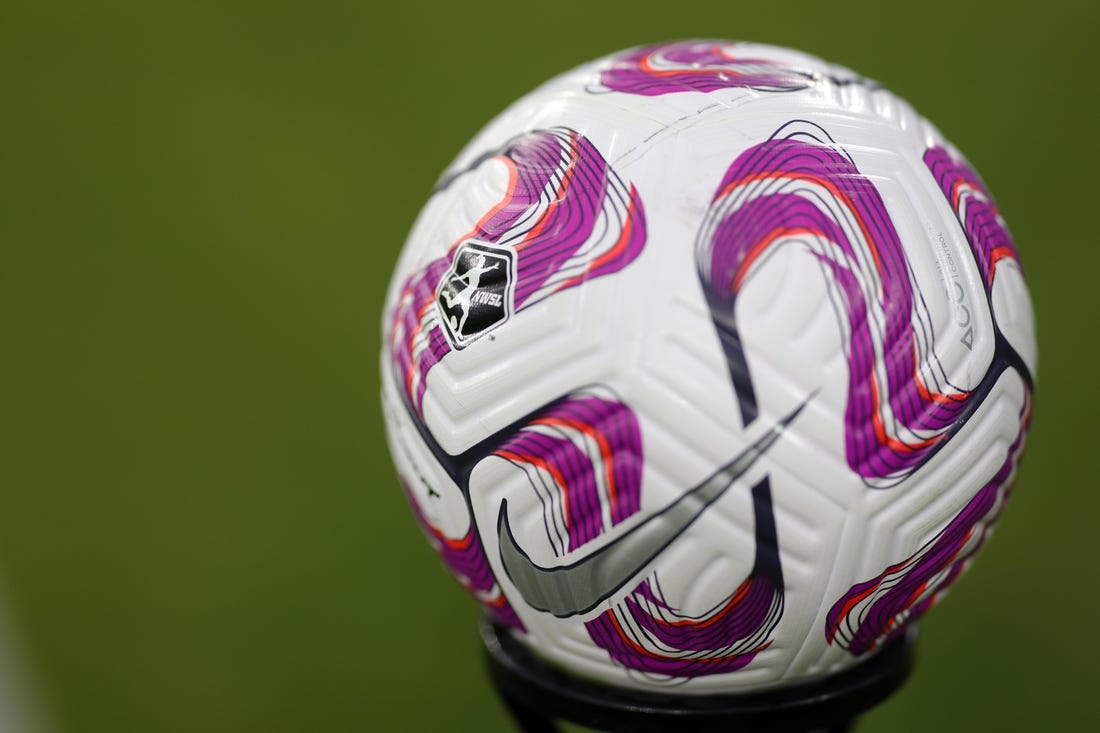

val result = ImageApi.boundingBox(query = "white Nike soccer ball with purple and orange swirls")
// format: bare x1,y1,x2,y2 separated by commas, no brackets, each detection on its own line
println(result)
382,41,1036,693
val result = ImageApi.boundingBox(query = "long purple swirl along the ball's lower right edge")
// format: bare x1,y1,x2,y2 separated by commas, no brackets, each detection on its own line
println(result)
825,391,1031,656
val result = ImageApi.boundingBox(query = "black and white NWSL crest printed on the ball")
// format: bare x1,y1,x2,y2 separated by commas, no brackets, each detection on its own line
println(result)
436,236,516,349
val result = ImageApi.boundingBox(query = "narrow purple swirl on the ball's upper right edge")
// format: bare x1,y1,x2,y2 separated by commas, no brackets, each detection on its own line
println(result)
924,146,1022,293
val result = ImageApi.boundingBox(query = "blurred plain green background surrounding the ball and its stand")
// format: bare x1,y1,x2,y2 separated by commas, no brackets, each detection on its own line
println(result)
0,0,1100,733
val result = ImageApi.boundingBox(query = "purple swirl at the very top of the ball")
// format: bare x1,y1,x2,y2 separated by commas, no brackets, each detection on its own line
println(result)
600,41,813,97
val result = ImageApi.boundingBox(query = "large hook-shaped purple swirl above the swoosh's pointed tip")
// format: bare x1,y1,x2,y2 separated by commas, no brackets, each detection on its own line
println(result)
696,121,976,488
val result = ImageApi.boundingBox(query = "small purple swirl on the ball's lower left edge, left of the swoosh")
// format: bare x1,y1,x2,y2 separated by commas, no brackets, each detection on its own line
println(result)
402,480,526,631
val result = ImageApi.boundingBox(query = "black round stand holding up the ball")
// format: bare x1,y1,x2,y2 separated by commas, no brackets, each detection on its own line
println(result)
481,619,916,733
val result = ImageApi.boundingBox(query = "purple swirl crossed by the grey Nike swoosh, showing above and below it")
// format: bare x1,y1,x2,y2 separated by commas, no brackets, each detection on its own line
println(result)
494,389,783,677
